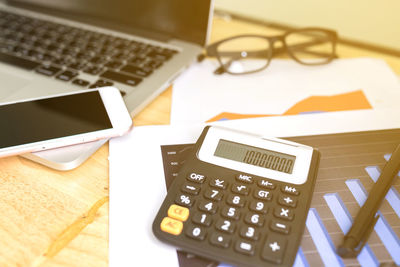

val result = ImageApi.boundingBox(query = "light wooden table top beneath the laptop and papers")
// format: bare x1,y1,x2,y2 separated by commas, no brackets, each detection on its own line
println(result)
0,13,400,267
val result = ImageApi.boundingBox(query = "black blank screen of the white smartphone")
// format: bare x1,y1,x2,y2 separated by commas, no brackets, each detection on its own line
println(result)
0,91,112,148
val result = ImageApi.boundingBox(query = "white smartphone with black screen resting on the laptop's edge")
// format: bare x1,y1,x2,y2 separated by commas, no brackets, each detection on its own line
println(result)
0,87,132,157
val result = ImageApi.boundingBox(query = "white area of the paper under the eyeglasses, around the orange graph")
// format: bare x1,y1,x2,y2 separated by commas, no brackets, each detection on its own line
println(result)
171,58,400,124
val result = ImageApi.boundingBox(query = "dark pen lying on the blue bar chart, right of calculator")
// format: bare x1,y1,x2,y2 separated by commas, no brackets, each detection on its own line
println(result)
337,145,400,258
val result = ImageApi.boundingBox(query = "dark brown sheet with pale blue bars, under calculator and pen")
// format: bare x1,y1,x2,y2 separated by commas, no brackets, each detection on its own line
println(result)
162,129,400,266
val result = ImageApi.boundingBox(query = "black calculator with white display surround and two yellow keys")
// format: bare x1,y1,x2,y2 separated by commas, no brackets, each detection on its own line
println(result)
153,126,320,266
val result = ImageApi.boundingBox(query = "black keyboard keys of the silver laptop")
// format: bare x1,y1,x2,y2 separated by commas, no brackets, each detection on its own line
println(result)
0,10,177,93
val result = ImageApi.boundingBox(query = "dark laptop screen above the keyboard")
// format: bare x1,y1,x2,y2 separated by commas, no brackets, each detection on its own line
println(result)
8,0,211,45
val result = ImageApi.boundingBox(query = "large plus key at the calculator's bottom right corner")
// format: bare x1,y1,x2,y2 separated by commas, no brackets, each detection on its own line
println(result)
261,233,286,264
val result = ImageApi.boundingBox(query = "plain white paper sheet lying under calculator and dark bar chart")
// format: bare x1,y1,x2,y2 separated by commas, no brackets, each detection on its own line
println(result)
109,108,400,267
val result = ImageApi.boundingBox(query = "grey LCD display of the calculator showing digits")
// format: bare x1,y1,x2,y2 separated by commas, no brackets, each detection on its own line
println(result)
214,139,296,174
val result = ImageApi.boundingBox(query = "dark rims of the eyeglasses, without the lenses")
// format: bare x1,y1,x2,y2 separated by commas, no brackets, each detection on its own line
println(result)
203,27,338,75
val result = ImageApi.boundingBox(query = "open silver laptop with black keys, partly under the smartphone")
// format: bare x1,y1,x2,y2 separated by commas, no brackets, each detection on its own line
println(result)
0,0,213,169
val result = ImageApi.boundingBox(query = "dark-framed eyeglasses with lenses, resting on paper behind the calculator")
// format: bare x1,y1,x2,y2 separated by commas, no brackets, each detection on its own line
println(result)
206,28,337,75
